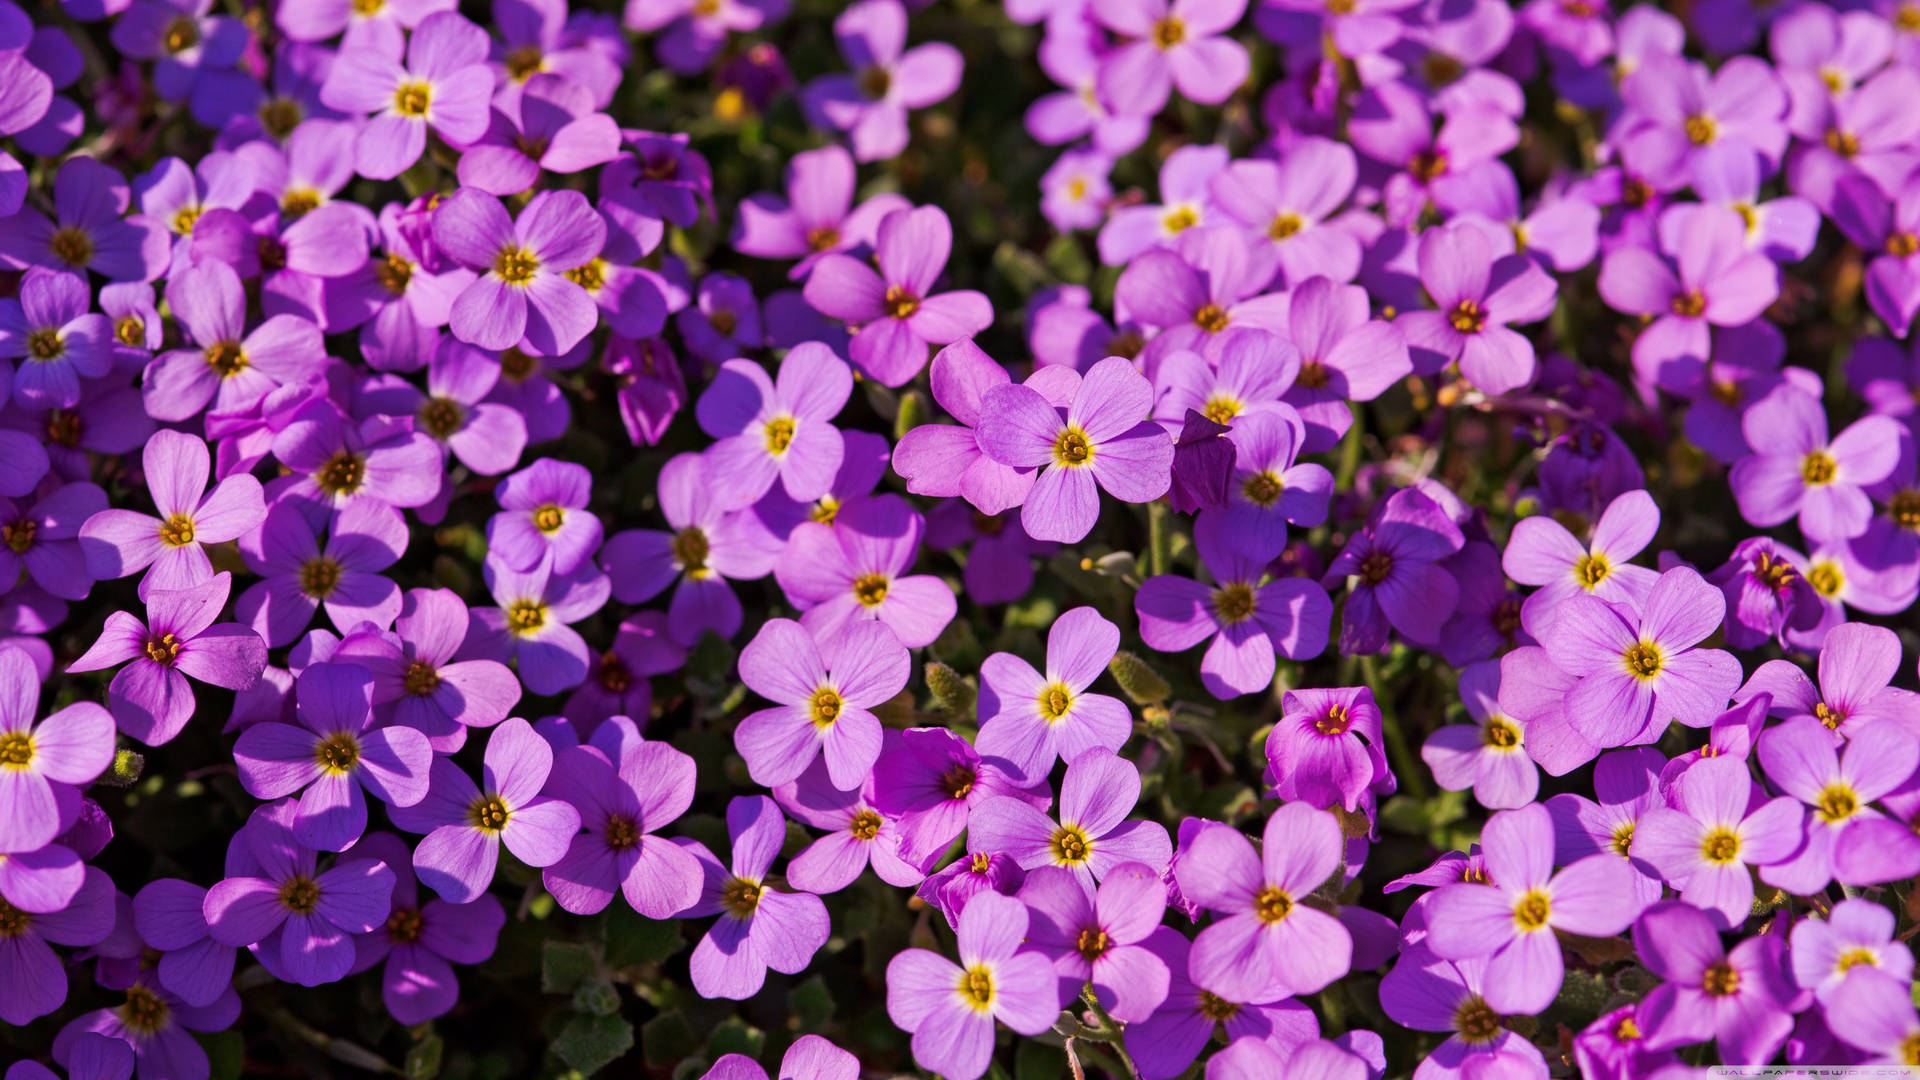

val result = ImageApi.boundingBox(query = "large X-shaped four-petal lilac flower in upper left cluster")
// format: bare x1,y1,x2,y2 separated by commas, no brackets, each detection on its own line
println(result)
435,186,607,356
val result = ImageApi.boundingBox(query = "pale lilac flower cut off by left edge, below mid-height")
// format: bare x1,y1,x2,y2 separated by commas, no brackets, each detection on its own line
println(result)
0,650,113,853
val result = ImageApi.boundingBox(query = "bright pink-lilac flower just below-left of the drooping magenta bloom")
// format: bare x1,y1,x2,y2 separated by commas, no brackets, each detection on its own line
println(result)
1175,803,1354,1001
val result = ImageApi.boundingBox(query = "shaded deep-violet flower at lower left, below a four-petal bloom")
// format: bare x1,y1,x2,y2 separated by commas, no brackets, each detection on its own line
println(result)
204,799,394,986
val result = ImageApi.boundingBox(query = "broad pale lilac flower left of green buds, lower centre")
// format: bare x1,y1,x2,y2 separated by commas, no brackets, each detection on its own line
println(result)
733,619,912,790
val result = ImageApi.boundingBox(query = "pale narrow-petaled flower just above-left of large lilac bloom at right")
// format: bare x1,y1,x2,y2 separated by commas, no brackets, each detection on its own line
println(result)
1500,490,1661,638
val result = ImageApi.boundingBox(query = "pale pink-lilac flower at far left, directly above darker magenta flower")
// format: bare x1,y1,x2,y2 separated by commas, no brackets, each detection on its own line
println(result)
81,430,267,598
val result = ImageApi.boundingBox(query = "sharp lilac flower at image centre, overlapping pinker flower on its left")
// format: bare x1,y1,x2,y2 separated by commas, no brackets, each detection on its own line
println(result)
977,356,1173,544
